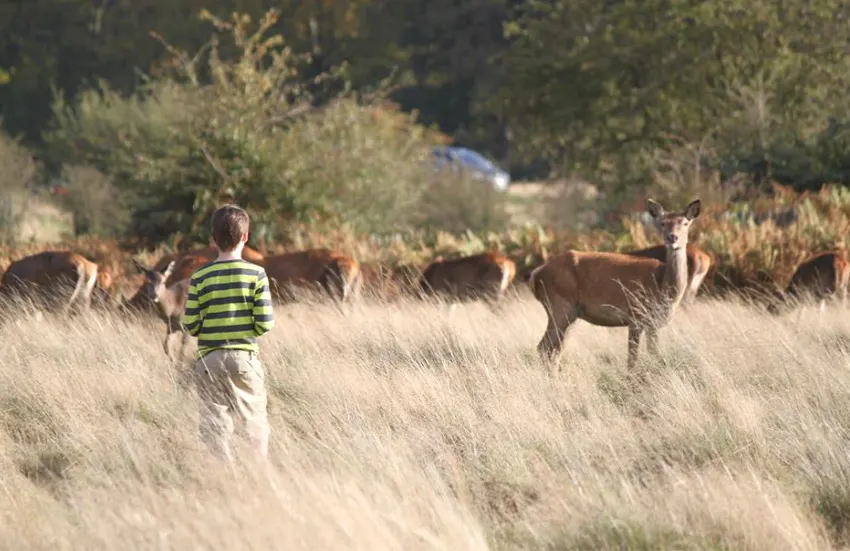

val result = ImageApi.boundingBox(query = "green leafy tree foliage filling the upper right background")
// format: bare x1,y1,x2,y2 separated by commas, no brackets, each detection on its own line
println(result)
491,0,850,194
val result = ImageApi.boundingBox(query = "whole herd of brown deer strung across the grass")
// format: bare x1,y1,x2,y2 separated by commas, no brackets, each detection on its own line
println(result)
0,196,850,374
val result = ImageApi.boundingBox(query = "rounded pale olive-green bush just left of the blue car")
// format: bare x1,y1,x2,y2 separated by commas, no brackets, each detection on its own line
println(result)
264,98,433,233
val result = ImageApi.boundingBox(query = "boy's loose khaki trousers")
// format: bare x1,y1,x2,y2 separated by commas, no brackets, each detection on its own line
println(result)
195,349,270,461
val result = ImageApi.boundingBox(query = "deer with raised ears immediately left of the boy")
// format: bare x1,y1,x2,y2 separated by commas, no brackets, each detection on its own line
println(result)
126,260,191,360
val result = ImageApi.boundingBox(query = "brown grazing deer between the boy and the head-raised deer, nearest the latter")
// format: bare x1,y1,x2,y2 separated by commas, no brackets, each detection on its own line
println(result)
419,252,516,312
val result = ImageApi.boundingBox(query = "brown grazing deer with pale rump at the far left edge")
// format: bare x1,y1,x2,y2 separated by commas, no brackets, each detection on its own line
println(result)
0,251,112,313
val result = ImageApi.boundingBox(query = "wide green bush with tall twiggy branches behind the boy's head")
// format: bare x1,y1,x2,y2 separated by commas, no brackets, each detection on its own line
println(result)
41,8,502,243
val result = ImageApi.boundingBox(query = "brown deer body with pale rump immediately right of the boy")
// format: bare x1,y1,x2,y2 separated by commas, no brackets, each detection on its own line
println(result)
264,249,361,302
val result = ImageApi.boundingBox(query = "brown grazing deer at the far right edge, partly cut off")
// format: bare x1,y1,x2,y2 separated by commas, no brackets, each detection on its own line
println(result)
768,250,850,314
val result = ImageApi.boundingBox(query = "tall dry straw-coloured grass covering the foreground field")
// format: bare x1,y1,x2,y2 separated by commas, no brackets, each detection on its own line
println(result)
0,296,850,550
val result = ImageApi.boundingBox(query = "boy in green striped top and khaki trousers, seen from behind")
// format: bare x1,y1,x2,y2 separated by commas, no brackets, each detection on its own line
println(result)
183,205,274,461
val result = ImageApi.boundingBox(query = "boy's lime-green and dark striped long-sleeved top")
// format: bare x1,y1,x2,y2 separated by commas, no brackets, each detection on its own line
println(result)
183,259,274,358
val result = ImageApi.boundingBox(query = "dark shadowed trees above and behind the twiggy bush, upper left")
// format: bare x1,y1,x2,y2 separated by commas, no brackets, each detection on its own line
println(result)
0,0,508,164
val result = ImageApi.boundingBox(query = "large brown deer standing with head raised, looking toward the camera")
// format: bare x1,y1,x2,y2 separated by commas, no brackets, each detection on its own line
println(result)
529,199,701,371
